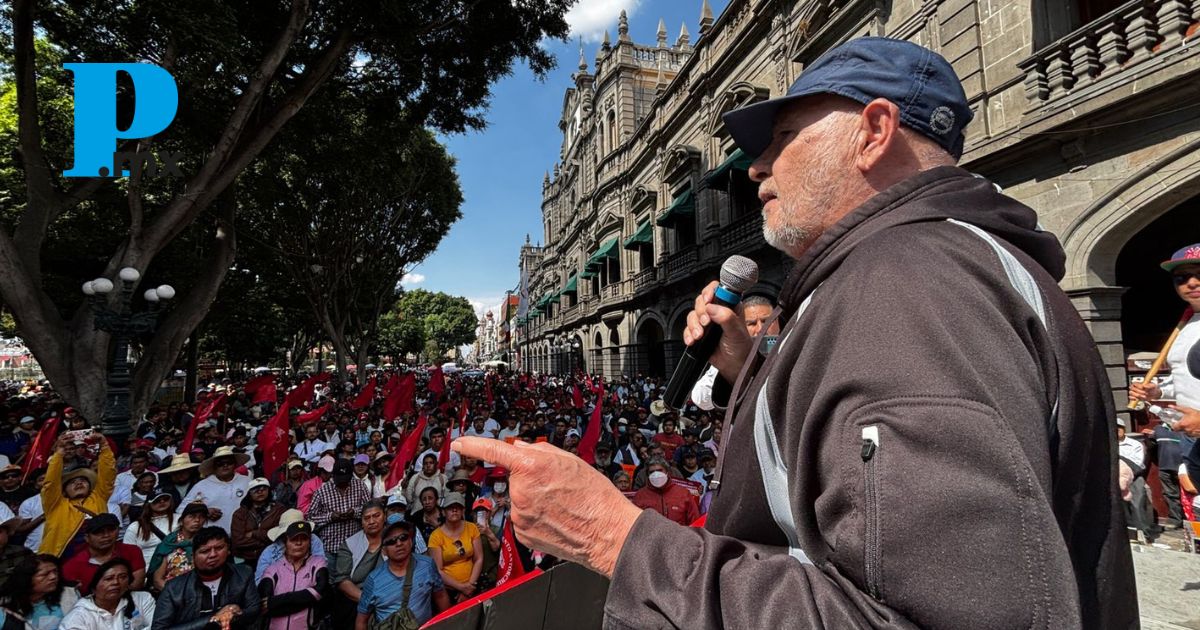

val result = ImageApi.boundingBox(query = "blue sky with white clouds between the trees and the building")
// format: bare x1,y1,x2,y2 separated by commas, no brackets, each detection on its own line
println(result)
404,0,728,312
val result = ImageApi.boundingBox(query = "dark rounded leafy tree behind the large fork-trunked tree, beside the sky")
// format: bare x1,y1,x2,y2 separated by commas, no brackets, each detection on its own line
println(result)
244,82,462,378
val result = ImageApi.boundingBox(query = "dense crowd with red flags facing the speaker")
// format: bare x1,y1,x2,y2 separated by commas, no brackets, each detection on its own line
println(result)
0,368,721,630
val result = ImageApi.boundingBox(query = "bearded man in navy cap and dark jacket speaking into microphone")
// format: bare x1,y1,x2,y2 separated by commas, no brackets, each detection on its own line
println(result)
455,37,1138,629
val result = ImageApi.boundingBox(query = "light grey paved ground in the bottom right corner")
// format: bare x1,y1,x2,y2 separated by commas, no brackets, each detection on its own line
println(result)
1133,533,1200,630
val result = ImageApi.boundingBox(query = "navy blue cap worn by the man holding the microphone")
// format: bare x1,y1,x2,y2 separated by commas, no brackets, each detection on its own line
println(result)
722,37,973,158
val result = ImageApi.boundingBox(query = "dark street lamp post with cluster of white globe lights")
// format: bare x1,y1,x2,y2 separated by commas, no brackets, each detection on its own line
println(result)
83,266,175,444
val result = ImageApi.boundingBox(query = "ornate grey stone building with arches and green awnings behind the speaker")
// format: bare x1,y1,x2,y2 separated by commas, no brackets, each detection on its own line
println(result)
520,0,1200,398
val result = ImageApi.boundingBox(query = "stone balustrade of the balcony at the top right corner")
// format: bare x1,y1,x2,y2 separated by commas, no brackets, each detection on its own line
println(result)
1018,0,1200,106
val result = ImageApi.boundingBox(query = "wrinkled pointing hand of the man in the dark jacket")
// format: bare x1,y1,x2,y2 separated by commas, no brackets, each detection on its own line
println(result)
450,436,643,577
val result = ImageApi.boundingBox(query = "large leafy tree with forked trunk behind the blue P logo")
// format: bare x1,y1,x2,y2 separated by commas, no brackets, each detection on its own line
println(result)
0,0,571,418
